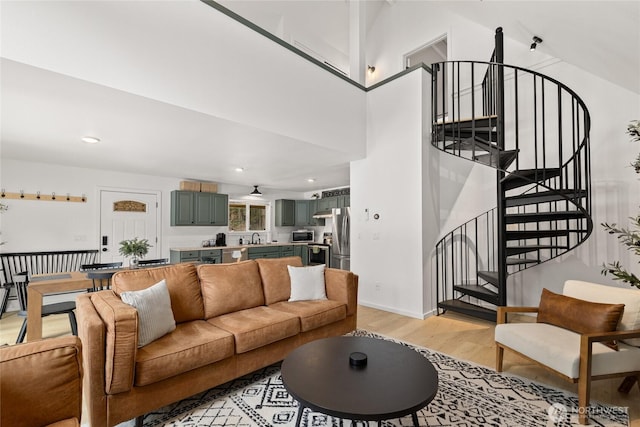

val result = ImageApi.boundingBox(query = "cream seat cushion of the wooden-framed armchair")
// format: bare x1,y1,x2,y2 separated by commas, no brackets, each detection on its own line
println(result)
495,323,640,378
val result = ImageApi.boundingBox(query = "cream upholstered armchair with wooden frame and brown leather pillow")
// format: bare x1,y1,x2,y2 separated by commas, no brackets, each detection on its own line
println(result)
495,280,640,424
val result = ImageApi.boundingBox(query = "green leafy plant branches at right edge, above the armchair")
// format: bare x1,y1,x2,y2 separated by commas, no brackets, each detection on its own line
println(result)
602,120,640,289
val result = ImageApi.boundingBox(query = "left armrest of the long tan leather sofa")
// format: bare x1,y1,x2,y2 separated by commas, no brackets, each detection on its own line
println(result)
84,290,138,394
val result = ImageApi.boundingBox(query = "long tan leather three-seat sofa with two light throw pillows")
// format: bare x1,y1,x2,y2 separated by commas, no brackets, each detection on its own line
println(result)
76,257,358,427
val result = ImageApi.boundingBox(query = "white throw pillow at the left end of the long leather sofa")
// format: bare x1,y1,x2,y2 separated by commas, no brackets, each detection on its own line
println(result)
120,279,176,348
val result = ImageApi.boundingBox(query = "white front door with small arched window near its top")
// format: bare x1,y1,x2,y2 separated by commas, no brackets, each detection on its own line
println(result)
100,190,161,266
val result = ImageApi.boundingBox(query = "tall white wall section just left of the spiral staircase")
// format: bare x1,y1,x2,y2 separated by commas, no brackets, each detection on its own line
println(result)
351,69,438,318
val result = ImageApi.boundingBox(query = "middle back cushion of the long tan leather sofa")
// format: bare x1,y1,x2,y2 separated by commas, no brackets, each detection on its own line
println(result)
198,261,264,319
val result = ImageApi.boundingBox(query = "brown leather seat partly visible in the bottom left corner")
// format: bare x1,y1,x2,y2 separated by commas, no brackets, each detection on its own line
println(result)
0,336,82,427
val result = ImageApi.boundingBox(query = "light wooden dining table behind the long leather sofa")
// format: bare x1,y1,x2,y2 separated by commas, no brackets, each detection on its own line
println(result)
27,269,120,341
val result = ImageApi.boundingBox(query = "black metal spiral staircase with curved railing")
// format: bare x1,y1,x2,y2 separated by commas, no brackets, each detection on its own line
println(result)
432,28,593,321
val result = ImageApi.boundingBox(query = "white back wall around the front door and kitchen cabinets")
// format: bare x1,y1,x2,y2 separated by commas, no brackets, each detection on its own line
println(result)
0,158,310,257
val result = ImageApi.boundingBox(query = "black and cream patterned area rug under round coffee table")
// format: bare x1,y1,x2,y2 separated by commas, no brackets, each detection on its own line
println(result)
127,330,629,427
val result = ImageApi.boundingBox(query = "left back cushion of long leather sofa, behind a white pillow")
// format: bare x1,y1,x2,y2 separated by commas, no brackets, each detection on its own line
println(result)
111,263,204,323
